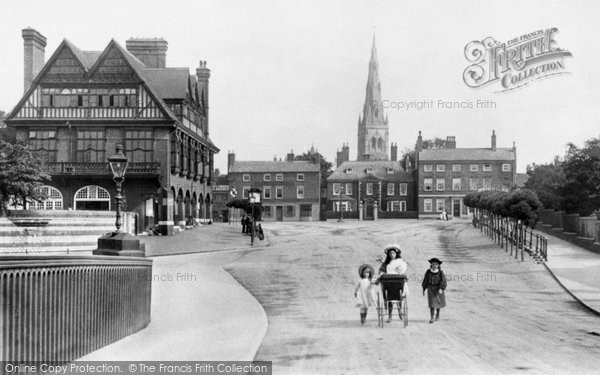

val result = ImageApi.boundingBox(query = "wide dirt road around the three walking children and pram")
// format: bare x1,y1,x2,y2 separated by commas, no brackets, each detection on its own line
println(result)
225,220,600,374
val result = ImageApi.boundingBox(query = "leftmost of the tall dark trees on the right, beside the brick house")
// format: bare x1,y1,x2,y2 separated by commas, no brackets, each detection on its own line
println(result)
525,157,567,209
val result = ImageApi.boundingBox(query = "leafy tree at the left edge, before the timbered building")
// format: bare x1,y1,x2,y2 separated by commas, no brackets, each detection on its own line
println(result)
0,140,50,216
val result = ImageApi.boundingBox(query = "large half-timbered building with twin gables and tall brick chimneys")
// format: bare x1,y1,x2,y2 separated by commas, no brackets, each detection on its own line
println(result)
6,29,219,234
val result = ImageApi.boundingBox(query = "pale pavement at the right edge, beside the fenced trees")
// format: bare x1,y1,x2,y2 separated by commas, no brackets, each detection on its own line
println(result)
540,233,600,315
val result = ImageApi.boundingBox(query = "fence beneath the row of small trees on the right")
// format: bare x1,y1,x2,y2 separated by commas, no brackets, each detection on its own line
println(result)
473,209,548,262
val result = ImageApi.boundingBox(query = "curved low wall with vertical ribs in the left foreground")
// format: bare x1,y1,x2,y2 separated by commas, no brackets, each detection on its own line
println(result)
0,256,152,362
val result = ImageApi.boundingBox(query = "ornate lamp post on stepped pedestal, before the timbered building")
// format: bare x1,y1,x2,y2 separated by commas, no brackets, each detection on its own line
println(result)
92,144,145,257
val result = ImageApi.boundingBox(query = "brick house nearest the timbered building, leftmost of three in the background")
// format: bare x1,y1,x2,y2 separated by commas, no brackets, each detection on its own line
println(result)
227,153,321,221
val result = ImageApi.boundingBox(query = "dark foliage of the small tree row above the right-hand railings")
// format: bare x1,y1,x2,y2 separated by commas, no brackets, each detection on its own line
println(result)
464,190,544,228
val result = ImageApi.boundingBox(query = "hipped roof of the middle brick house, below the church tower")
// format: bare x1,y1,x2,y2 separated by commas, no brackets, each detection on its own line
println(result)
327,161,412,181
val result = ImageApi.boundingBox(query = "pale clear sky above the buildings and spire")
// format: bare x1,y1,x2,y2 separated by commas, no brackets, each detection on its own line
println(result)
0,0,600,172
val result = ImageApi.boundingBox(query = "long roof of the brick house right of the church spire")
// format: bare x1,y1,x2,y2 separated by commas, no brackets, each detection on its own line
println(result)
419,148,516,161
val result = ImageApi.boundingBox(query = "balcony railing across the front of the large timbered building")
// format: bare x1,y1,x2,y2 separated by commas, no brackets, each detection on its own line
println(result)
44,162,160,175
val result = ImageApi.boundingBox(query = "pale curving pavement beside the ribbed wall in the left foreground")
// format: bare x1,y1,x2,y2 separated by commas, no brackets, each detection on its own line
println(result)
79,223,268,361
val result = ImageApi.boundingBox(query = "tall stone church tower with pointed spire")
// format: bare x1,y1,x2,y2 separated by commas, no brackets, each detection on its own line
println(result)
357,35,389,161
